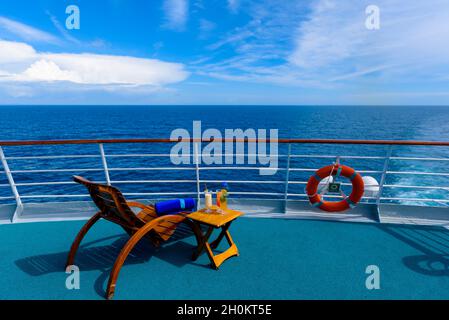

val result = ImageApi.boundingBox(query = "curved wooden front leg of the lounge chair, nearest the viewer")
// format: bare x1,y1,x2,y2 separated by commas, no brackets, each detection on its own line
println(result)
106,215,186,299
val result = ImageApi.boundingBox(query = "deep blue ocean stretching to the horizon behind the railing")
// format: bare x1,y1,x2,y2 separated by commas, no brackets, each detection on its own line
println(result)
0,106,449,203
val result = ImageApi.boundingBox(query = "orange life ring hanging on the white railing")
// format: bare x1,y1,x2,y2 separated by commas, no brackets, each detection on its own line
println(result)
306,164,365,212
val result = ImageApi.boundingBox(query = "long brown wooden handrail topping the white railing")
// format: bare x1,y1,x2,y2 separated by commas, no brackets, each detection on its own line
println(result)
0,138,449,146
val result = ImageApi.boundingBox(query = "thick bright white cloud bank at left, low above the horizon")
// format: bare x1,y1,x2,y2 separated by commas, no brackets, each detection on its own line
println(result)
0,41,188,89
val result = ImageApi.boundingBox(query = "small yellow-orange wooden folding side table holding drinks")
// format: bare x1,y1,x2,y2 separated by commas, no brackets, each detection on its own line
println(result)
187,206,243,270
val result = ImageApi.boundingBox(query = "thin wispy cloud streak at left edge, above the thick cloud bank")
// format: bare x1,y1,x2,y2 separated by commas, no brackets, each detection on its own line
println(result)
0,16,60,44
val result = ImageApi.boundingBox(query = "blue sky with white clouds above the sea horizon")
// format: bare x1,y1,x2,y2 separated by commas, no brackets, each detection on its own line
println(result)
0,0,449,105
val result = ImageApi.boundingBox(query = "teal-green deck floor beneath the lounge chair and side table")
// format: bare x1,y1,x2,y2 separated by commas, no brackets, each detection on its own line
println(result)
0,218,449,299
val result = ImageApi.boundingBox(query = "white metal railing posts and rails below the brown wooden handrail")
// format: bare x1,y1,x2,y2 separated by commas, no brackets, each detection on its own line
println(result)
0,142,449,221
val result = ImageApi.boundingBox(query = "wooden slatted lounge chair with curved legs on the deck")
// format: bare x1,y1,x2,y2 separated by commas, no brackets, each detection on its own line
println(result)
66,176,201,299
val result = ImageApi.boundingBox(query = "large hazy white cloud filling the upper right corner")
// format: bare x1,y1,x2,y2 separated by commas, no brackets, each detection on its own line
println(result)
289,0,449,80
